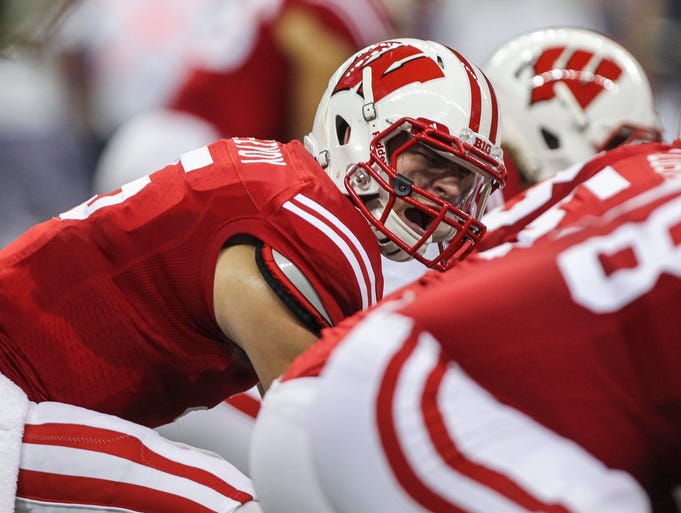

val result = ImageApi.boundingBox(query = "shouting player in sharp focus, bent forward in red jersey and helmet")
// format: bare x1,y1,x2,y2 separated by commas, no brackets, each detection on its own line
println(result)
0,39,505,513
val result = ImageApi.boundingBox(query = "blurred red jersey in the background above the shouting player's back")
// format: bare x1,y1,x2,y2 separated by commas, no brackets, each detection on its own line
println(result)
170,0,394,140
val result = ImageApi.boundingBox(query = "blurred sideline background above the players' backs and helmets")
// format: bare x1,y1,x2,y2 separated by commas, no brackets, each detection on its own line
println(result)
0,0,681,247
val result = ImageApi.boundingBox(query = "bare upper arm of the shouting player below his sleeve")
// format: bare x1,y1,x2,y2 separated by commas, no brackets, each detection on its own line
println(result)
213,244,317,392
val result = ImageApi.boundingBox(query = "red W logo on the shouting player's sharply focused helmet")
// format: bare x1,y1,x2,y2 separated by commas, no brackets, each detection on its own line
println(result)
333,42,445,102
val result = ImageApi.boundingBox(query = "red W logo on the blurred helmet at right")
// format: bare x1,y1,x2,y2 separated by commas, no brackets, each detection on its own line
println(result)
530,46,622,109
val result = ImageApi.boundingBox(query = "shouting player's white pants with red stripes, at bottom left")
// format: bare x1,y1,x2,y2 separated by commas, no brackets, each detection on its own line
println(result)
16,402,259,513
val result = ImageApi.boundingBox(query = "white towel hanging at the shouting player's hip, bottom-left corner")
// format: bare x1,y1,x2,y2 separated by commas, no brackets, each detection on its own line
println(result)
0,374,29,513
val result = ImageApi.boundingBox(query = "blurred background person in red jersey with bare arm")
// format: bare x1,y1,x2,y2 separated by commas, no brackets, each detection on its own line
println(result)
170,0,395,140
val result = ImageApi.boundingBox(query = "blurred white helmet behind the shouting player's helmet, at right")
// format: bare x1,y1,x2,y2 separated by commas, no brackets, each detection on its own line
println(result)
485,27,662,183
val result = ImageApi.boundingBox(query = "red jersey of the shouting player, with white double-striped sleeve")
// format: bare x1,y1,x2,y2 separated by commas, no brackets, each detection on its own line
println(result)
0,139,383,426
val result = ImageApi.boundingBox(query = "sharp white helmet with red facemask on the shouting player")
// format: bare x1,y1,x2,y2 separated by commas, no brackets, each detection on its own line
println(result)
305,39,506,270
